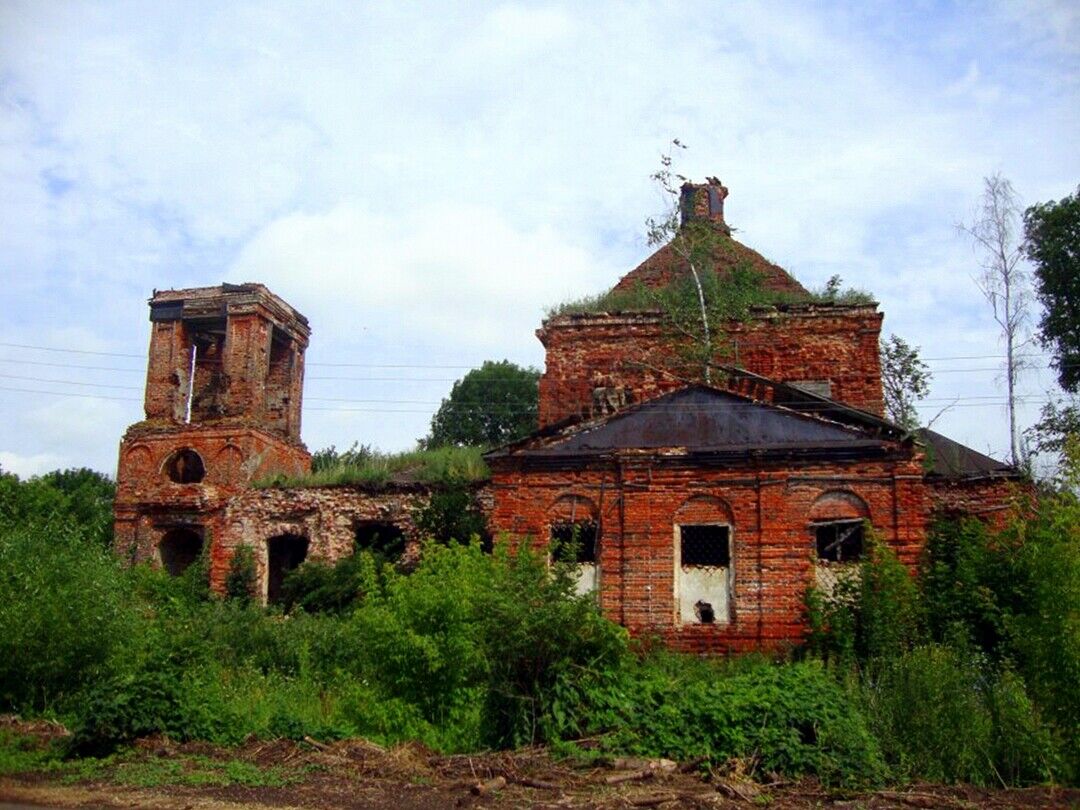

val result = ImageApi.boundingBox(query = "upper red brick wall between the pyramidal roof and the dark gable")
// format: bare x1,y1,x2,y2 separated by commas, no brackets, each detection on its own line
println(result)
537,307,883,427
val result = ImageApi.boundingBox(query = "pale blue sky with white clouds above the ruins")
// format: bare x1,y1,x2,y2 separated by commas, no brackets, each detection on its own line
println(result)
0,0,1080,475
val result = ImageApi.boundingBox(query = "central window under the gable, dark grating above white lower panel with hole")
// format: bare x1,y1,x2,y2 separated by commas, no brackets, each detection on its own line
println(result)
676,524,731,624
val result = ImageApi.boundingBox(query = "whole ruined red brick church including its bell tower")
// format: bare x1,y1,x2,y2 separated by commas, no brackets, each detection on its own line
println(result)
116,180,1022,651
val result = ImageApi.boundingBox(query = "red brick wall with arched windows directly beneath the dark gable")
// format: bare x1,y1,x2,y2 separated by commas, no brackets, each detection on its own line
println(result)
491,460,928,651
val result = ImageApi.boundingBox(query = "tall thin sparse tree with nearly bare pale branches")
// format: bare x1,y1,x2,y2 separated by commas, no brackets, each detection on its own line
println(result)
959,174,1030,464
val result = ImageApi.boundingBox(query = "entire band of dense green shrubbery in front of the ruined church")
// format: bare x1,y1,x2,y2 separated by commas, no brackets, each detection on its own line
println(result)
0,466,1080,786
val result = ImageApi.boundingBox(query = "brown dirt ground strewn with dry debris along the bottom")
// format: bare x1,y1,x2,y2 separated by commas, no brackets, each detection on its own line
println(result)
0,725,1080,810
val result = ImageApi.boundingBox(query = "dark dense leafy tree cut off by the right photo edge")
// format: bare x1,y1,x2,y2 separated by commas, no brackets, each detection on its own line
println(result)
1024,187,1080,393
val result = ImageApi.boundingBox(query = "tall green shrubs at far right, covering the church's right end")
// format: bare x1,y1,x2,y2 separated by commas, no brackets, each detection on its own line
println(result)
807,492,1080,784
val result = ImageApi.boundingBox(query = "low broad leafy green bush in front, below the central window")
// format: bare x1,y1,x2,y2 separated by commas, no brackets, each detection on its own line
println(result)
602,653,887,786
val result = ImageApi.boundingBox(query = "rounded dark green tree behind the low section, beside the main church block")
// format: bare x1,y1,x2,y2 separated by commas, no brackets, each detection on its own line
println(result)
422,360,540,448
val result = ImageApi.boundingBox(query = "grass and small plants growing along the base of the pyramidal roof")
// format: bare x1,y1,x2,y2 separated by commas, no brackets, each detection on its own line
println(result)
544,262,876,320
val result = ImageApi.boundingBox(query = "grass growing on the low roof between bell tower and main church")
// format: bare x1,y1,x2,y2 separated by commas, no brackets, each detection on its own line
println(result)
254,444,490,489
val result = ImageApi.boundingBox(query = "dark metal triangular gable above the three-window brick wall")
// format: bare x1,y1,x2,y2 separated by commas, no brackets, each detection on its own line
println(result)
488,386,897,468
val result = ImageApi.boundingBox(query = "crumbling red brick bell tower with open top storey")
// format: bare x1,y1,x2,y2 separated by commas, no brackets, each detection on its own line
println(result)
116,284,311,581
